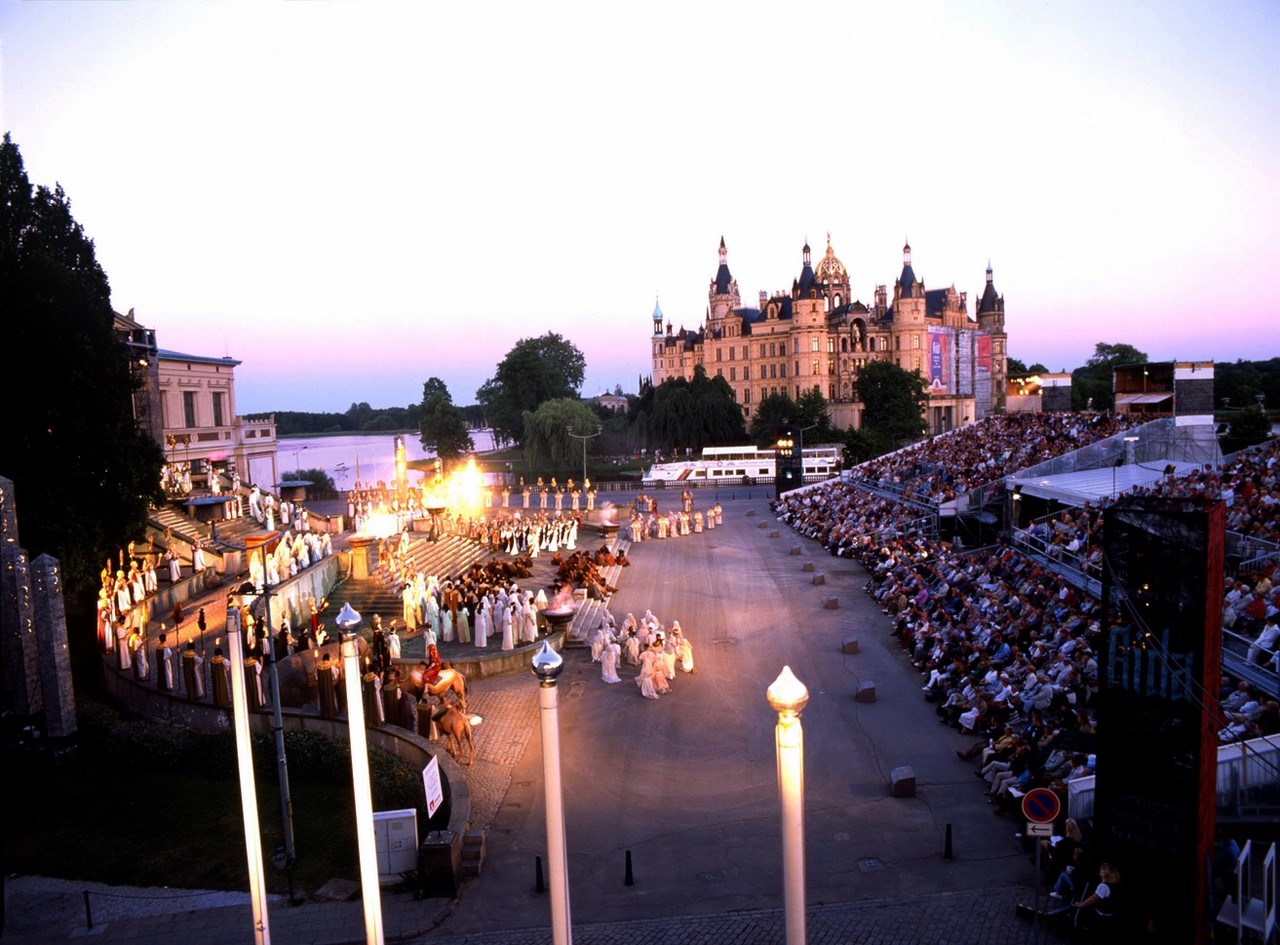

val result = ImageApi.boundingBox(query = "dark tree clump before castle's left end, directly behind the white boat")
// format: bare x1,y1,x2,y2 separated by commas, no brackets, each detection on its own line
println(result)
630,365,746,452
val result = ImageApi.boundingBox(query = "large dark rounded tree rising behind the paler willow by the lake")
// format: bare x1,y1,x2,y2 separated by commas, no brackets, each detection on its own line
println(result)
476,332,586,443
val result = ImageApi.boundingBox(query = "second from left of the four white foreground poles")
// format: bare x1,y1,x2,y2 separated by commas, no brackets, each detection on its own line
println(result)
337,601,383,945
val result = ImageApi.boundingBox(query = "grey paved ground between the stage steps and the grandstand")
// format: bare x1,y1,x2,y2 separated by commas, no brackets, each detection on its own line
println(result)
4,489,1056,945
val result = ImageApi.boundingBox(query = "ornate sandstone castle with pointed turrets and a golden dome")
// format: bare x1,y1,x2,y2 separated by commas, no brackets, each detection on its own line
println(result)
652,234,1007,433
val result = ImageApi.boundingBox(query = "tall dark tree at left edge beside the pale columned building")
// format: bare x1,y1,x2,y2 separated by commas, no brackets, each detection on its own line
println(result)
0,134,164,607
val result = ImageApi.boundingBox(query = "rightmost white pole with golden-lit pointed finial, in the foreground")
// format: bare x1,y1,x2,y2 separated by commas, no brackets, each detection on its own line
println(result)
764,666,809,945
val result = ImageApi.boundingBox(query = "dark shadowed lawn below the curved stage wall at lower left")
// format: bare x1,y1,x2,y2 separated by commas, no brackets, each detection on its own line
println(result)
5,707,426,895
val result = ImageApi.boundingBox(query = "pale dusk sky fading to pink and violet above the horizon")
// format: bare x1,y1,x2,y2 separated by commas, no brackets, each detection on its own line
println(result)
0,0,1280,414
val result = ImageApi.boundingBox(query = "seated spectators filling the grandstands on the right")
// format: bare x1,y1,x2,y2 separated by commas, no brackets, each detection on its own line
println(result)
776,415,1280,911
